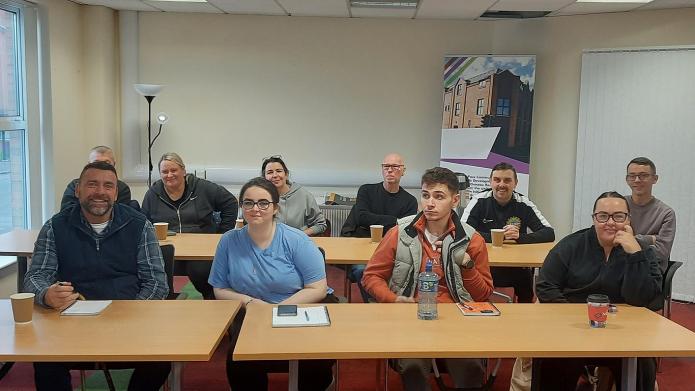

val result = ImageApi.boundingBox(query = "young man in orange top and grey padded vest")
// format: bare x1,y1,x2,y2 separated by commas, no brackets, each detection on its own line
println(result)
362,167,492,390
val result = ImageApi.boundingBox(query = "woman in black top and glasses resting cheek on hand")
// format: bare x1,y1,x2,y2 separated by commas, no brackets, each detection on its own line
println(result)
533,191,664,391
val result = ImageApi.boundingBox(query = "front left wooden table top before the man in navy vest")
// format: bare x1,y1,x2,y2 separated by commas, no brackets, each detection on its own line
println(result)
0,300,239,361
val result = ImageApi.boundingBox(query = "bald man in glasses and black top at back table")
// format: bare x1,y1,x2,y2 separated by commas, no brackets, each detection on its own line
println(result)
340,153,417,303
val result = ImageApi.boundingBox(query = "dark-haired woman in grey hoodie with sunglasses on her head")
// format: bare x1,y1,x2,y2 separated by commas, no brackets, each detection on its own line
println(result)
261,155,326,236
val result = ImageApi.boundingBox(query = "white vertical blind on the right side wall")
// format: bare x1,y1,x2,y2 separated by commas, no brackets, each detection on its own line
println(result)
573,47,695,301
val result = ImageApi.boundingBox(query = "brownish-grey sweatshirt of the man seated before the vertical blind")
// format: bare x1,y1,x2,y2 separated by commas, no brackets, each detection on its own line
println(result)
625,196,676,270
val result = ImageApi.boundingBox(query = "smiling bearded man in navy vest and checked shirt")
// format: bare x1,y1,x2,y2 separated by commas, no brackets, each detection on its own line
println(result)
24,161,171,391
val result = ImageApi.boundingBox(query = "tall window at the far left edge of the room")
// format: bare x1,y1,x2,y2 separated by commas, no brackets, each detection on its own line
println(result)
0,3,28,233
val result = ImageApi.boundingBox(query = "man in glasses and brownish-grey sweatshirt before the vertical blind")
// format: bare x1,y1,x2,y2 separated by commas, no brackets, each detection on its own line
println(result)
625,157,676,271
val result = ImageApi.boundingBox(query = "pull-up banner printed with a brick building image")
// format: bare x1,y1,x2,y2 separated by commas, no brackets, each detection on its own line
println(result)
440,56,536,198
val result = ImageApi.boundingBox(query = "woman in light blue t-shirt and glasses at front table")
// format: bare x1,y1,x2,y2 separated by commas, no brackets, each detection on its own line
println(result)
208,177,333,390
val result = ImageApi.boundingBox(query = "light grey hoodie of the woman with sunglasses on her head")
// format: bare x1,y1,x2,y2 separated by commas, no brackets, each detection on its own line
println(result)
278,183,326,235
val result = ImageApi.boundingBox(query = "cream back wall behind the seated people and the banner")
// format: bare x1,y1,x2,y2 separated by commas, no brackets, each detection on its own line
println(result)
121,9,695,240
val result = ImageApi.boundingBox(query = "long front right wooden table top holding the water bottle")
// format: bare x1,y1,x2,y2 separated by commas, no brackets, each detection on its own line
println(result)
234,304,695,360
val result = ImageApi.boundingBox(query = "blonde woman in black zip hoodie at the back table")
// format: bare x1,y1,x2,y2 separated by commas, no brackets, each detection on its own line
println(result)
142,152,238,299
